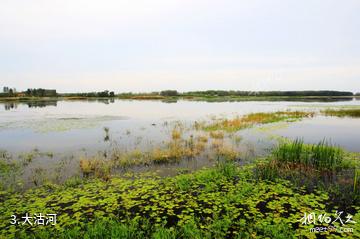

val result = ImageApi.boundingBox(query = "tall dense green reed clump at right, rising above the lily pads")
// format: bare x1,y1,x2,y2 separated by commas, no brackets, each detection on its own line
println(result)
254,139,360,211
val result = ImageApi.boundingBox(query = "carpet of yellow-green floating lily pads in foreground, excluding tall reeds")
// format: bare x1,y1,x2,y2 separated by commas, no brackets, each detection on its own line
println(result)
0,162,360,238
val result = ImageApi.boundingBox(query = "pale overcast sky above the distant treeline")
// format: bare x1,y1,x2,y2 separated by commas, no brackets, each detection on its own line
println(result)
0,0,360,92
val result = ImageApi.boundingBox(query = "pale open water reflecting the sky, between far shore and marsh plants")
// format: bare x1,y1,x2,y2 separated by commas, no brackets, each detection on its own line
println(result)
0,100,360,153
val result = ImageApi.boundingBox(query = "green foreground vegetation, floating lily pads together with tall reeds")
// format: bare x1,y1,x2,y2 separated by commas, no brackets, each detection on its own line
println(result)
0,141,360,238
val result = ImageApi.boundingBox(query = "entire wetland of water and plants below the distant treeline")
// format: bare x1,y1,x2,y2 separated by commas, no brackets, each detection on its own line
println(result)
0,99,360,238
